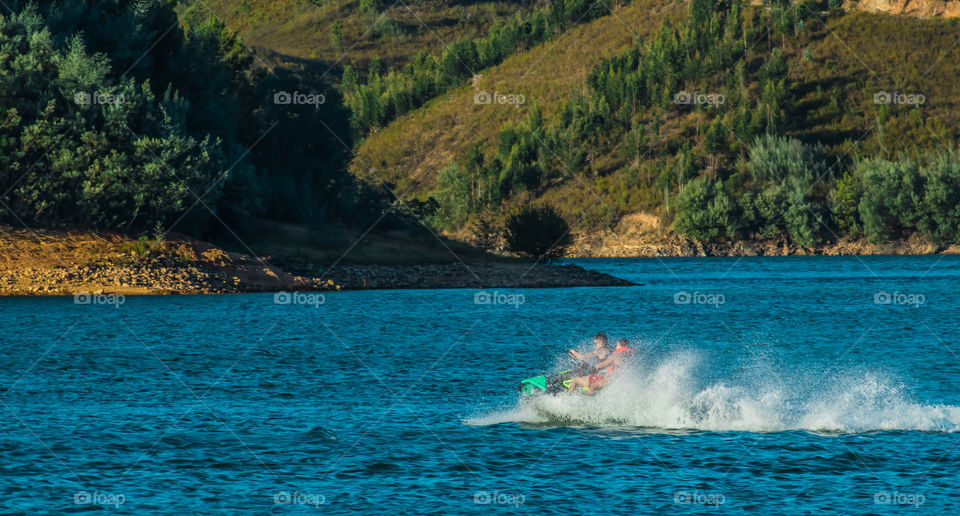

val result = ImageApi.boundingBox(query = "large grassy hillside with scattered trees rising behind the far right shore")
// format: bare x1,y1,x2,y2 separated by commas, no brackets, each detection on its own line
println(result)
350,1,960,245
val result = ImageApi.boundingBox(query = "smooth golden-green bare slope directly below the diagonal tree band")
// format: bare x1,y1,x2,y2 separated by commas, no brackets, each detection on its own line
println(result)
350,0,684,191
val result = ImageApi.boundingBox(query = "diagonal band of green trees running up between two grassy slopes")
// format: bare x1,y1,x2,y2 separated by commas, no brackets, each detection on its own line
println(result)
341,0,612,134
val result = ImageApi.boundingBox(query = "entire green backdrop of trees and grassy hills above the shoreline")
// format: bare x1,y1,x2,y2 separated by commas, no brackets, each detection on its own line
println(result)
0,0,960,261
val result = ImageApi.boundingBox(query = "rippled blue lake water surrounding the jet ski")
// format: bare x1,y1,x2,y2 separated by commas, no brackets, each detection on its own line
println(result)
0,257,960,514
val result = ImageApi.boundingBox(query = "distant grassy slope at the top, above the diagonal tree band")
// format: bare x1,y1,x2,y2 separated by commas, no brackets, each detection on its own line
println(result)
189,0,529,75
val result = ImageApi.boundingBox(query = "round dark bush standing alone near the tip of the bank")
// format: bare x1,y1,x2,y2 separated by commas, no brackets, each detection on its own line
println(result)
506,205,573,261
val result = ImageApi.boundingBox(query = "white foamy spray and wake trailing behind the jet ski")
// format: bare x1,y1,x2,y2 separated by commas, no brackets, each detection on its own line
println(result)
465,352,960,433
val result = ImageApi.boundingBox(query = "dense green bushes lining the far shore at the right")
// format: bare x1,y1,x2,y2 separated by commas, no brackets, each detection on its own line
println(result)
674,136,960,247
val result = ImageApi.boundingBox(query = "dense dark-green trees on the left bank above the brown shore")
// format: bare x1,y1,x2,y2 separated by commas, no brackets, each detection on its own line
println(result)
0,0,394,233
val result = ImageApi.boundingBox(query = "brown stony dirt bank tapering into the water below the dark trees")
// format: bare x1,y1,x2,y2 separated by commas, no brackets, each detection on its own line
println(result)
0,226,630,295
